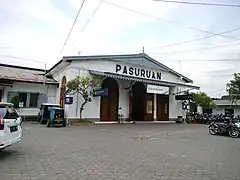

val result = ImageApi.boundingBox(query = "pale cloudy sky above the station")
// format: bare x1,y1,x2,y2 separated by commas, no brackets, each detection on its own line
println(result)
0,0,240,97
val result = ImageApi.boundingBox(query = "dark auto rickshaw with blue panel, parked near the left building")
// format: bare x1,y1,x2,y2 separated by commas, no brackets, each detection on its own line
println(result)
37,103,66,127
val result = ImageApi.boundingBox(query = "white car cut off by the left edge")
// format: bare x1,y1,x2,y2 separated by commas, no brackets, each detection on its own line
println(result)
0,102,22,150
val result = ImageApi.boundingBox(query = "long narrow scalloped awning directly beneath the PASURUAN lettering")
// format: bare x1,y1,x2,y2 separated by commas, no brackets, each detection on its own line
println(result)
89,70,200,89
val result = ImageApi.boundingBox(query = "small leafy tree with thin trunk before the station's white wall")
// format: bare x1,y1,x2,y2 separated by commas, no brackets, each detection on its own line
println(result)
67,76,102,120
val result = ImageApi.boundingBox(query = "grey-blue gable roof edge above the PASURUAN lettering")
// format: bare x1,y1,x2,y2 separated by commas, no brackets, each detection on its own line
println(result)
47,53,193,83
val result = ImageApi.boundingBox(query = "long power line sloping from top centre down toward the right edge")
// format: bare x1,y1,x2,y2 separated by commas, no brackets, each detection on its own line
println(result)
103,0,236,40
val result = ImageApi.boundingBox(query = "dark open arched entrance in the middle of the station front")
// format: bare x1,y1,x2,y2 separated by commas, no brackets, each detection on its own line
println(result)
130,82,146,121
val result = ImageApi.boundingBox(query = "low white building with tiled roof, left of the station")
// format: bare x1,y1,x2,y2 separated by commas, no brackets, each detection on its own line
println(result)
0,64,58,117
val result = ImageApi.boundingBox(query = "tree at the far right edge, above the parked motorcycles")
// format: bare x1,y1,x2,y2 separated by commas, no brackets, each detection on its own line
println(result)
227,73,240,103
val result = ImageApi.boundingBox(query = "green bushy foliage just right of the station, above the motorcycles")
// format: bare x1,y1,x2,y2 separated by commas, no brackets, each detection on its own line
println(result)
192,92,216,109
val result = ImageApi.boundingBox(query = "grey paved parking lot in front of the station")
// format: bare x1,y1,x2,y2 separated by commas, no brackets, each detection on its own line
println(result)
0,122,240,180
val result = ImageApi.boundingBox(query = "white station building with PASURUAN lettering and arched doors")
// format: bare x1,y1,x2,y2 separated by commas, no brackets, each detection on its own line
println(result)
47,54,199,121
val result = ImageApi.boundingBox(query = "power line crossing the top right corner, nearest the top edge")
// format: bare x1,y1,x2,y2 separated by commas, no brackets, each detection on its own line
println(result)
153,0,240,8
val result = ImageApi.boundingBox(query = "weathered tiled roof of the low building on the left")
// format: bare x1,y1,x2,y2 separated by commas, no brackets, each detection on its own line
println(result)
0,64,58,84
